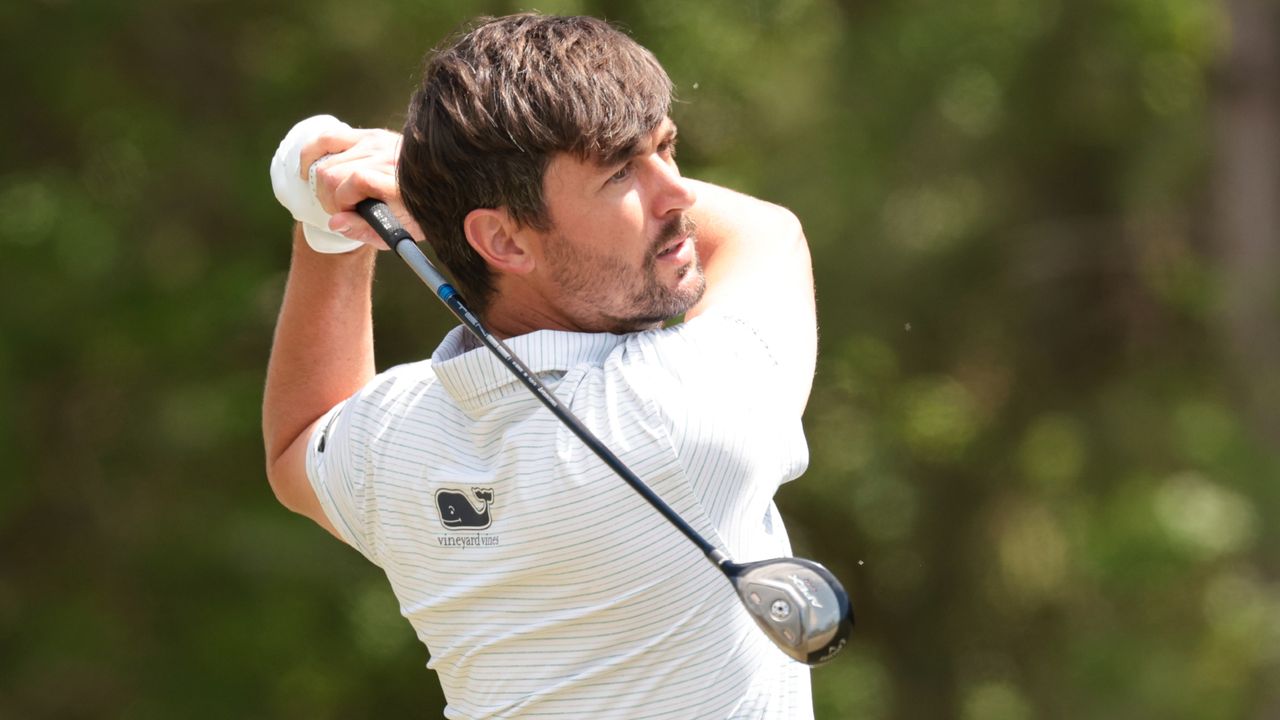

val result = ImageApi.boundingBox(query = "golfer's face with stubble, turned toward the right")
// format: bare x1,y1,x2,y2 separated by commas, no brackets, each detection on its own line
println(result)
540,119,705,332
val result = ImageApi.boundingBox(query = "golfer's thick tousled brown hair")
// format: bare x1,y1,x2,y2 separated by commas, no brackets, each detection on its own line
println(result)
399,13,672,311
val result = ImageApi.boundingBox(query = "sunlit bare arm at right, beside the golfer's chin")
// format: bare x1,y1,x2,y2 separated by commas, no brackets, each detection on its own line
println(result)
685,181,818,411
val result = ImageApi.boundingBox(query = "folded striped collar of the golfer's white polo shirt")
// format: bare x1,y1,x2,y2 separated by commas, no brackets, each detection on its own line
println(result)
431,325,626,413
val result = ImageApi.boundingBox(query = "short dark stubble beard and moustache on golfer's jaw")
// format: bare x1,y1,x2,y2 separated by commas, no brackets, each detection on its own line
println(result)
547,215,707,333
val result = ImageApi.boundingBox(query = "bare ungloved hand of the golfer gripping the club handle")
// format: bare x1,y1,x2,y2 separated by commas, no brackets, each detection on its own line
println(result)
300,127,424,250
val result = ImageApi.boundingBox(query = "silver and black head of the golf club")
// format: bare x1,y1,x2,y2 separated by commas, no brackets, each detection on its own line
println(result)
728,557,854,665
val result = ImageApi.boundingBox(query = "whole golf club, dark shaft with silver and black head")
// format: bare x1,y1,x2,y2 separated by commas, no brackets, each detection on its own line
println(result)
356,200,854,665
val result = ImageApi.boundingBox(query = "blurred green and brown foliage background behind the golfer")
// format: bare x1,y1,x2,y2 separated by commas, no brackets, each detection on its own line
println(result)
0,0,1280,720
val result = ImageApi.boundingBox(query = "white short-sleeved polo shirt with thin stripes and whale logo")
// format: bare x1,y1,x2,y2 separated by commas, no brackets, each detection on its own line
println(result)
307,314,813,720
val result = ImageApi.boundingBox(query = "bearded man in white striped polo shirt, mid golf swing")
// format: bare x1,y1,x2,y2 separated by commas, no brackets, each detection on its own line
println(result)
264,14,817,719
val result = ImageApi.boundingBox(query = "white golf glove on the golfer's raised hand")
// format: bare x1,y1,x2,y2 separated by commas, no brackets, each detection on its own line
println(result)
271,115,364,254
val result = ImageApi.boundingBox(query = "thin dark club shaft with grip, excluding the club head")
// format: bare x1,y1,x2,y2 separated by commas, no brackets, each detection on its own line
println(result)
356,200,730,566
